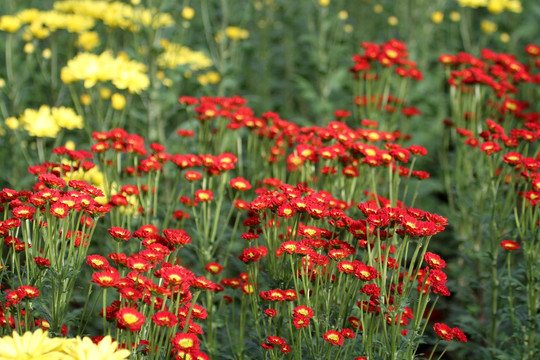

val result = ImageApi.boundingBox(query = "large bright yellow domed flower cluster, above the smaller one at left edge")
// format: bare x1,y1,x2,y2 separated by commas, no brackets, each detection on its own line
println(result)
60,51,150,94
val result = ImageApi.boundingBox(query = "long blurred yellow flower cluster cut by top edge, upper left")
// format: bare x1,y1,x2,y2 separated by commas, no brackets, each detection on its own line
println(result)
54,0,175,31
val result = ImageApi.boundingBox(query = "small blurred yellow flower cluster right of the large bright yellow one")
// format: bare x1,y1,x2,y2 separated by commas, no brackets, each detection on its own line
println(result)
157,40,212,71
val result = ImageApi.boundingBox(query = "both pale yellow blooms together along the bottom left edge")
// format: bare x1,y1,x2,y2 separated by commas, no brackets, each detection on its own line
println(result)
0,329,130,360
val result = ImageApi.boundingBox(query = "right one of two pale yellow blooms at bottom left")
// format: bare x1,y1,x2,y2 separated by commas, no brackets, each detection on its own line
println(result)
62,336,131,360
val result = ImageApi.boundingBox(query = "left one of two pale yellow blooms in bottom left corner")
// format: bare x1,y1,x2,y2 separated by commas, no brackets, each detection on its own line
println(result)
0,329,68,360
